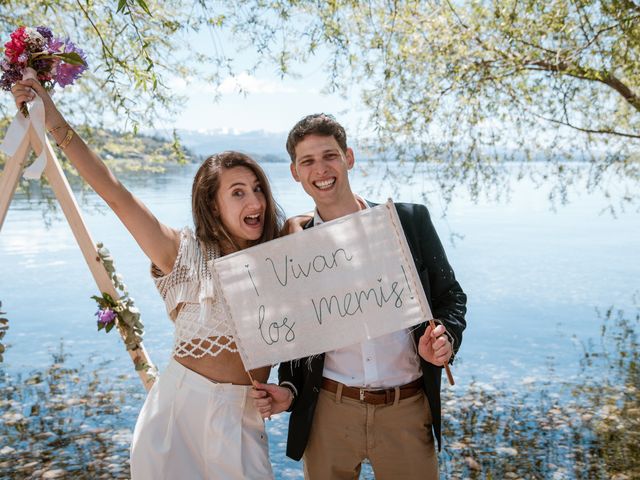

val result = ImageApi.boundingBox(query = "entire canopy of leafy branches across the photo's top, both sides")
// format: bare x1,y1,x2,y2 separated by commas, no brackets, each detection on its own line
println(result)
0,0,640,199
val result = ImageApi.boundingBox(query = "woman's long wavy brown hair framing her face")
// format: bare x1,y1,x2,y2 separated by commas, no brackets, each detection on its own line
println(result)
191,151,284,253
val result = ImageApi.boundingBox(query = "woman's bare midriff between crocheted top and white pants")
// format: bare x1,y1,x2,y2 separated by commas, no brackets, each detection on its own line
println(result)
174,350,271,385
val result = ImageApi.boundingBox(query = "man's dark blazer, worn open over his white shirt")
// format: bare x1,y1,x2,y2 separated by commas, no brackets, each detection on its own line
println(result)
278,202,467,460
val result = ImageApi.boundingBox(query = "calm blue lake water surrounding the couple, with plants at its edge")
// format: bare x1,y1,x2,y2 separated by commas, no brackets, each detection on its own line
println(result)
0,164,640,478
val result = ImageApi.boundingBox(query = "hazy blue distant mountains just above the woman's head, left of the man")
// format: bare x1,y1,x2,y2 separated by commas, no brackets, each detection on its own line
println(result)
151,130,288,162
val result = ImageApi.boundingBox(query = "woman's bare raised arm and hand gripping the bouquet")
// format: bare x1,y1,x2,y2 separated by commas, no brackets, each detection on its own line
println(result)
11,80,180,273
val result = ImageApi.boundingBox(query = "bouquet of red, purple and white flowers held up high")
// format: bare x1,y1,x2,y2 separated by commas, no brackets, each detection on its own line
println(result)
0,26,87,117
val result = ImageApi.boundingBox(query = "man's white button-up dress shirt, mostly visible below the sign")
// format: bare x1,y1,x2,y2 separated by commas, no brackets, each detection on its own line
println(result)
313,195,422,388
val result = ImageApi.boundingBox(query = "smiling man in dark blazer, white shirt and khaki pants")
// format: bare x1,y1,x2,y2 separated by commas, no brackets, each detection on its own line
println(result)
253,114,466,480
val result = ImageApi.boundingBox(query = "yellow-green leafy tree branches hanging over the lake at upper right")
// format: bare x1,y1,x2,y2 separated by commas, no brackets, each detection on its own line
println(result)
214,0,640,202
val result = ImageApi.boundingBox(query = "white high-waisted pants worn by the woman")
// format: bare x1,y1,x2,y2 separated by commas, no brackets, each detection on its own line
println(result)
131,359,273,480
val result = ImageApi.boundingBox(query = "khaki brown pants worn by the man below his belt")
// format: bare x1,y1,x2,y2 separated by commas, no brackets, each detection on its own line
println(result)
303,388,438,480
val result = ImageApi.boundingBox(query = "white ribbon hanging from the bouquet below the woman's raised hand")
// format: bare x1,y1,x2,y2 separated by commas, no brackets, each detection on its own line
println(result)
0,72,47,180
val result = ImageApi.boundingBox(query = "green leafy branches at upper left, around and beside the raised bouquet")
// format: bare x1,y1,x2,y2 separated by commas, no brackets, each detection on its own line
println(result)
0,0,198,131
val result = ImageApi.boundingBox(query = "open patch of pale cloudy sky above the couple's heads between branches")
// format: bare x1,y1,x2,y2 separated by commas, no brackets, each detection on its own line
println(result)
159,26,366,135
